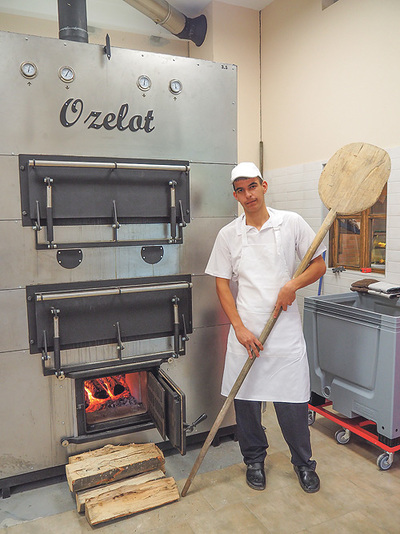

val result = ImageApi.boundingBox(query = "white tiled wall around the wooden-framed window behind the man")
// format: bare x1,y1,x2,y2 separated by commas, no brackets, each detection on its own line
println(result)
265,147,400,316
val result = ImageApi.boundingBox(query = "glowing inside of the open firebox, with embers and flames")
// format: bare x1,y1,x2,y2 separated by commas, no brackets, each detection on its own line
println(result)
84,371,147,425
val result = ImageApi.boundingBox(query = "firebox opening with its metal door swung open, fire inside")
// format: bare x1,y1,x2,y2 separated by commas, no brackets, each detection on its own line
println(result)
74,364,186,454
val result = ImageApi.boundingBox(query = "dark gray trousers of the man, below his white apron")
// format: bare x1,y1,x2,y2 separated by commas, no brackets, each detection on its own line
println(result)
235,399,316,469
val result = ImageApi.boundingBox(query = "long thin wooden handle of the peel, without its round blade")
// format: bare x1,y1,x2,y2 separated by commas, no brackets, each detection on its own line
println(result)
181,209,337,497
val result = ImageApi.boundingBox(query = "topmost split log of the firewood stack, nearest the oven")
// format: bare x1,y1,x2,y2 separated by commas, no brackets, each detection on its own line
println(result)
65,443,165,492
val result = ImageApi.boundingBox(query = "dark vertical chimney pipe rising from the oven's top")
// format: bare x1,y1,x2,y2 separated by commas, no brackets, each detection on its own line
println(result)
57,0,89,43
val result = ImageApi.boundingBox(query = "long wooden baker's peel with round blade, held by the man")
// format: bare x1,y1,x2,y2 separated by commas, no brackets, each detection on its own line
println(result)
181,143,390,497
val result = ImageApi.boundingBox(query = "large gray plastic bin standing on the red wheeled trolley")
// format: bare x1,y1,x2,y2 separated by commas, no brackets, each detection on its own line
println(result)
303,292,400,440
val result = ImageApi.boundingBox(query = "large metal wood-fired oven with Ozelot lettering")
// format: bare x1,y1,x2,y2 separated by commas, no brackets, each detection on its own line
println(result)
0,28,236,497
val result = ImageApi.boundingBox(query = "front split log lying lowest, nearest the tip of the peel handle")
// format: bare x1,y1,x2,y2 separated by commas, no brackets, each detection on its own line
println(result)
85,477,179,526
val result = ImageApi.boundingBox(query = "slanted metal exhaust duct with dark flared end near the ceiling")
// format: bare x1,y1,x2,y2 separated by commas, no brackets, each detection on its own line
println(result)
124,0,207,46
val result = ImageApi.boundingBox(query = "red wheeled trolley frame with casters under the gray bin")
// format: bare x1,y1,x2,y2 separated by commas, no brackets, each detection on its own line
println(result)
308,401,400,471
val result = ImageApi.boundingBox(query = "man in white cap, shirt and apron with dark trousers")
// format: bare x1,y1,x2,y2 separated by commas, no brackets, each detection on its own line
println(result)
206,162,326,493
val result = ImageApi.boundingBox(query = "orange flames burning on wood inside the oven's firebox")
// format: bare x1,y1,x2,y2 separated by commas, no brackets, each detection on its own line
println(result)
84,375,131,413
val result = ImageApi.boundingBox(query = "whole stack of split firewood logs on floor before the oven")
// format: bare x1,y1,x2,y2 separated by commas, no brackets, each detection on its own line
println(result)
65,443,179,526
